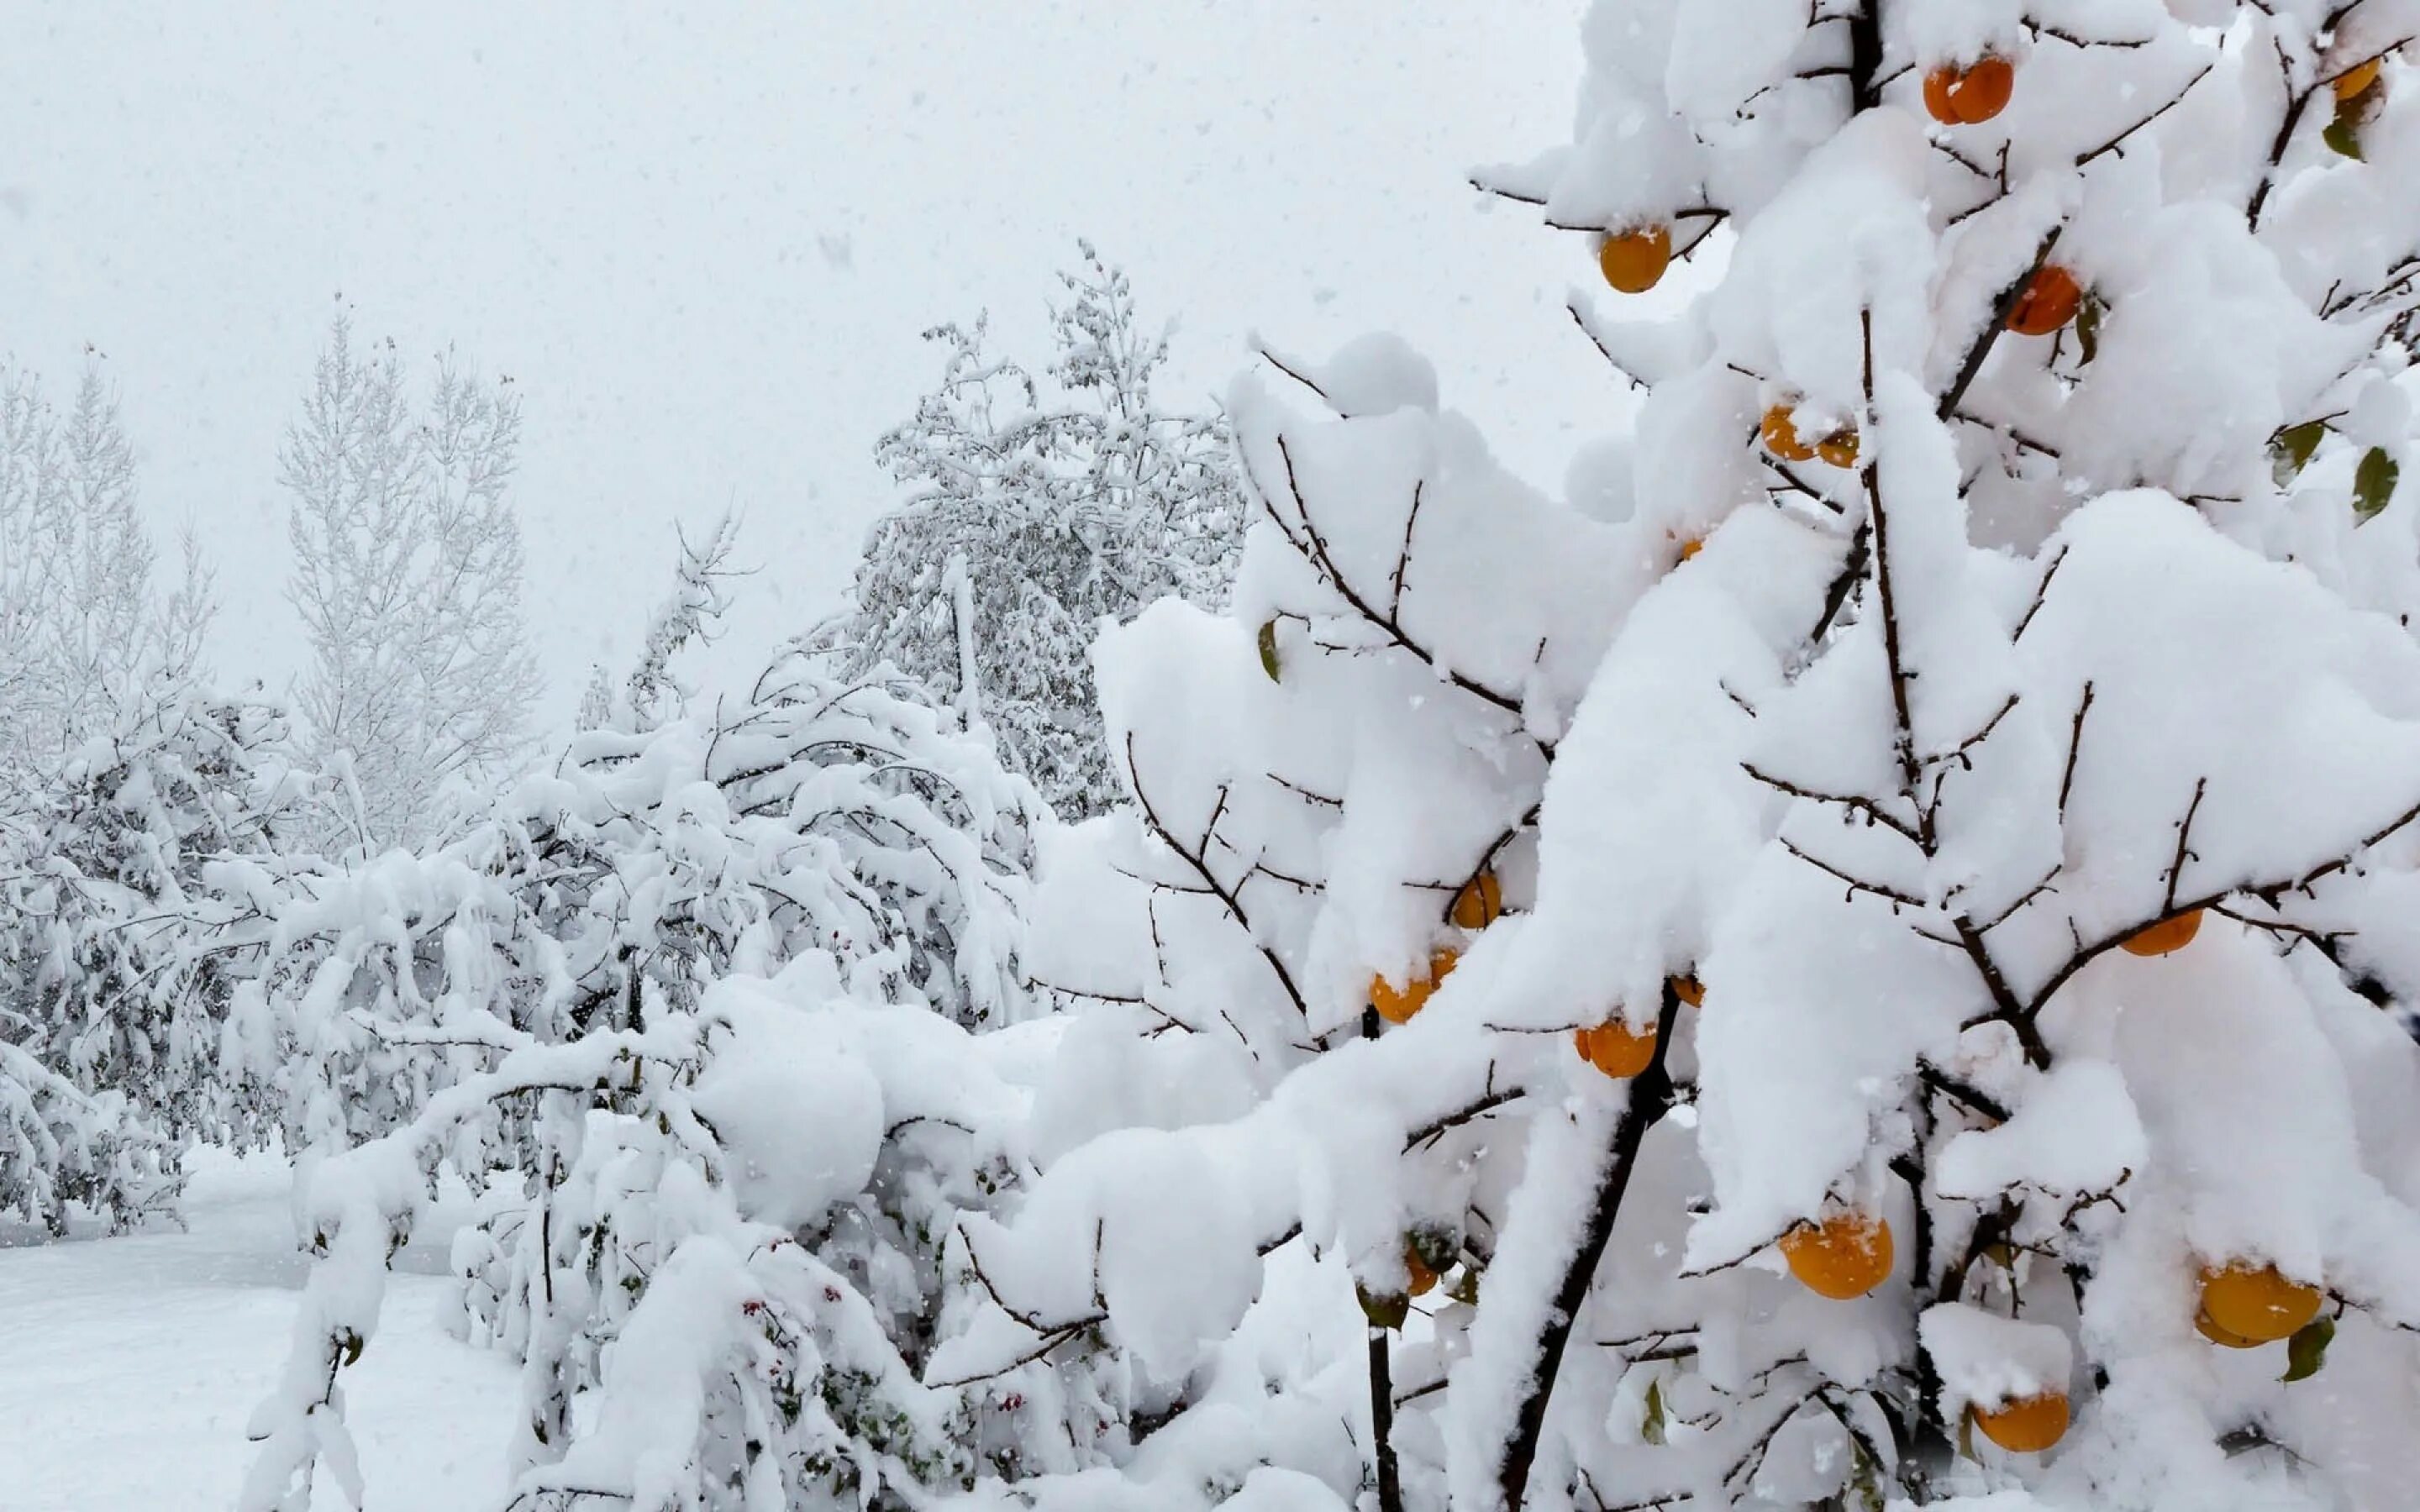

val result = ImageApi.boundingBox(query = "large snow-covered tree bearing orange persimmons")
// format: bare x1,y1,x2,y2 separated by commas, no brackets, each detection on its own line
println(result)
963,0,2420,1512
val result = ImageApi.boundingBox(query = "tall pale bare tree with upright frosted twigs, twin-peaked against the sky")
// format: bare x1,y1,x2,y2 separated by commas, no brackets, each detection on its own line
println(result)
278,314,537,849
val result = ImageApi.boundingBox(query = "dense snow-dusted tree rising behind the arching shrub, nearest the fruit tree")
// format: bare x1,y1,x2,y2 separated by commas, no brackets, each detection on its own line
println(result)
825,244,1244,817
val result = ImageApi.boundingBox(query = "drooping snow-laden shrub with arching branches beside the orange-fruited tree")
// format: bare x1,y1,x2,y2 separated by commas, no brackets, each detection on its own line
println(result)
247,654,1060,1507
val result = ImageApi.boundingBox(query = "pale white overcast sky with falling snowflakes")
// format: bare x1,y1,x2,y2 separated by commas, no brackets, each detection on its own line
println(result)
0,0,1623,718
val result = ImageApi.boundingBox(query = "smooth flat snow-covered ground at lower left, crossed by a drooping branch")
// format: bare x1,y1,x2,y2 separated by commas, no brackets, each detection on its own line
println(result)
0,1152,513,1512
